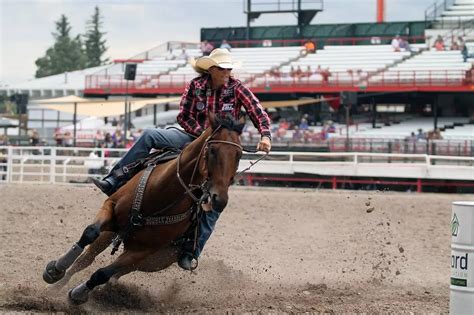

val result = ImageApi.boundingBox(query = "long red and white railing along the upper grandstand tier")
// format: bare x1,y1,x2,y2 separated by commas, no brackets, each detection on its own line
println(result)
86,70,474,94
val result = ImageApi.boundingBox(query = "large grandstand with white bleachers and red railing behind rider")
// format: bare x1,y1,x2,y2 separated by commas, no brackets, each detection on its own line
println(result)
0,0,474,149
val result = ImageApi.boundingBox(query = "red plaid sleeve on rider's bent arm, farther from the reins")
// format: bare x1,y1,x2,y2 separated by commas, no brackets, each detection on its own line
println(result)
176,80,202,136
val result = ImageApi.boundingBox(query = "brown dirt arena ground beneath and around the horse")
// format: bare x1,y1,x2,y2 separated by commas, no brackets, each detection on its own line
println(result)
0,185,474,314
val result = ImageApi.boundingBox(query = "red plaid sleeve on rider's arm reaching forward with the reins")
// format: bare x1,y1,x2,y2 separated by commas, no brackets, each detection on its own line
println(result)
236,84,272,139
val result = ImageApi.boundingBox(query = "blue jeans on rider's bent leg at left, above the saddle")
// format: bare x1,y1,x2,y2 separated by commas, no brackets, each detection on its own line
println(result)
104,128,194,186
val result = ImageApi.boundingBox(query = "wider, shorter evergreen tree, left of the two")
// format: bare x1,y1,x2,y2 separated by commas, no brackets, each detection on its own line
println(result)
35,14,86,78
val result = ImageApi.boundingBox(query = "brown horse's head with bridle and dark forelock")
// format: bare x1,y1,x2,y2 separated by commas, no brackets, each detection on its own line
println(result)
201,114,245,211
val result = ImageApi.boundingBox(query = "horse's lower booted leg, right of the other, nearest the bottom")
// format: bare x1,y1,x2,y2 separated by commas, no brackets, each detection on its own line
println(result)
68,250,152,305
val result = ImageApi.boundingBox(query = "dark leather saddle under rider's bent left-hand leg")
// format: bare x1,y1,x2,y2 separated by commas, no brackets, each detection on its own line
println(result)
112,147,181,182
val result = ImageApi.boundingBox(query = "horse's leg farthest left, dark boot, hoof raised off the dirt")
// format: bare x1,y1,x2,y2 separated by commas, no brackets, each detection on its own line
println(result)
43,199,114,284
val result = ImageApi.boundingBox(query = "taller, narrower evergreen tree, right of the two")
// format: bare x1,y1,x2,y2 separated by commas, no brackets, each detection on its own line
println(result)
84,7,109,67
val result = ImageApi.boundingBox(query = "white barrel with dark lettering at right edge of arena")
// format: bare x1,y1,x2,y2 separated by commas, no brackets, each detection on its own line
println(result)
449,201,474,315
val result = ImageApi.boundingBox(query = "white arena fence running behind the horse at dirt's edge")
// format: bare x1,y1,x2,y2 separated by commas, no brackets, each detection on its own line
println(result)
0,146,474,184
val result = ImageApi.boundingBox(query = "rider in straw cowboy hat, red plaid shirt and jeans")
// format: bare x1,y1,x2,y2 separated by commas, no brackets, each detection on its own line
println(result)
91,48,271,270
